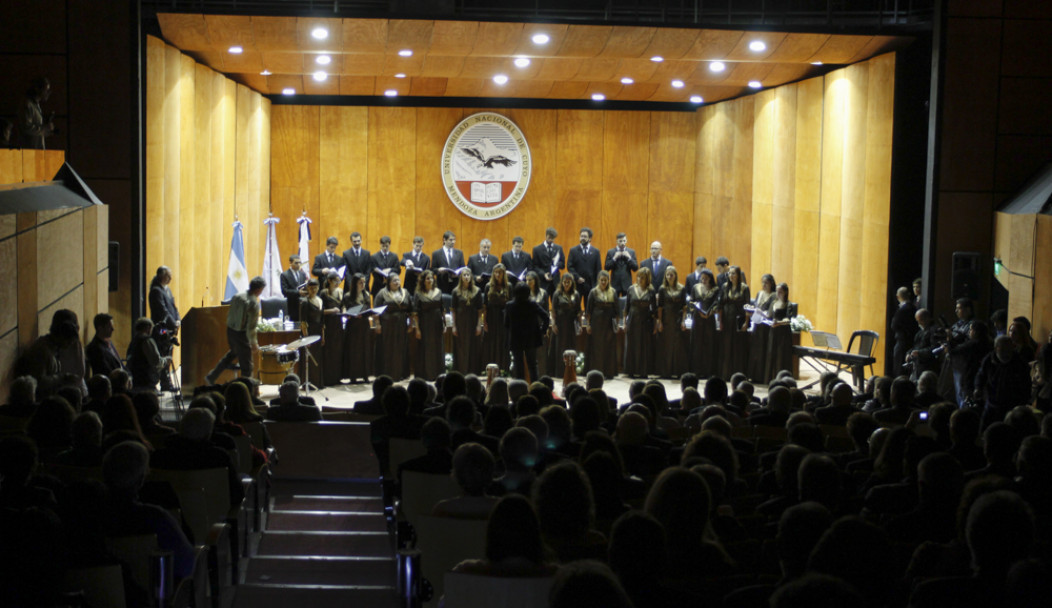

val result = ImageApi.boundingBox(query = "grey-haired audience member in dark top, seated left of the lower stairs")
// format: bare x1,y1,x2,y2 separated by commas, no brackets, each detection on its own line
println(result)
102,441,194,581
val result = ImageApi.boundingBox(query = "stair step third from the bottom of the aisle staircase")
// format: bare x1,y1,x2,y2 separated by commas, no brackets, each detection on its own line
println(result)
256,530,395,558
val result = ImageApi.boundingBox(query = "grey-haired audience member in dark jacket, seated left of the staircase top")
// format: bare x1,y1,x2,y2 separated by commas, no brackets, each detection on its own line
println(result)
150,408,245,506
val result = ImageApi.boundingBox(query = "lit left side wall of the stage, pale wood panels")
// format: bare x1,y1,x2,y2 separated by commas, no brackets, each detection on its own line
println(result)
143,37,270,323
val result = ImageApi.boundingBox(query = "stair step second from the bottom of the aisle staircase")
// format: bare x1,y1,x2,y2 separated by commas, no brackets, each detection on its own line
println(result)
245,555,398,587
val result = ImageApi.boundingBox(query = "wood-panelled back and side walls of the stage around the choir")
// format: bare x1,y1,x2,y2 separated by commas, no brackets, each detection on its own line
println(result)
147,33,895,369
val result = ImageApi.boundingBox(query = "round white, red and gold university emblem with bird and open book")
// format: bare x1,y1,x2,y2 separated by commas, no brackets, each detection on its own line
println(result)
442,112,533,220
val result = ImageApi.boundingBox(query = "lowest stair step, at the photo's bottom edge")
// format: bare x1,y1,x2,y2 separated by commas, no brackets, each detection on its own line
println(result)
234,583,398,608
